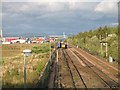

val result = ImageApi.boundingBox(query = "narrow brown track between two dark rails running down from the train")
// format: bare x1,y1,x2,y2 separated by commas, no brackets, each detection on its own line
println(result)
63,50,87,90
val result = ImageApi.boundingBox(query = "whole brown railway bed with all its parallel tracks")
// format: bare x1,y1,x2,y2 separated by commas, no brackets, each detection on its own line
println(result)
48,46,118,90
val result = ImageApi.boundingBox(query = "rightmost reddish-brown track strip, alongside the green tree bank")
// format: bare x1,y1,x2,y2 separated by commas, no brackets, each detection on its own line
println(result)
73,48,120,82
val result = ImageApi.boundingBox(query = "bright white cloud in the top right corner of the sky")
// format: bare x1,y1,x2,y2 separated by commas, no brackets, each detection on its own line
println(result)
94,0,118,13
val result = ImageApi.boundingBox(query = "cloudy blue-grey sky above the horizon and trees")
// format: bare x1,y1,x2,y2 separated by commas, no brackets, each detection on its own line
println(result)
0,0,119,35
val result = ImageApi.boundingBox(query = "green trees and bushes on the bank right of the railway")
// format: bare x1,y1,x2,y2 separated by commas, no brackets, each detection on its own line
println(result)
68,26,118,61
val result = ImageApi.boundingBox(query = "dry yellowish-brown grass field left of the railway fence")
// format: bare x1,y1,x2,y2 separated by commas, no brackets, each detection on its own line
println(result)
2,44,50,88
